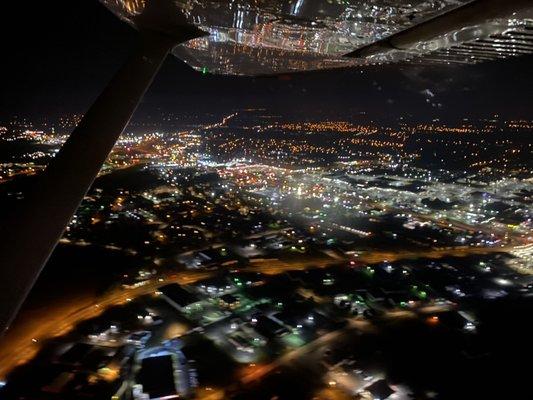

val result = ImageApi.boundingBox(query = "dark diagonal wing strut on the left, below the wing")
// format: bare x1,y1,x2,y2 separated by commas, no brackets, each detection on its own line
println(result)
0,31,179,335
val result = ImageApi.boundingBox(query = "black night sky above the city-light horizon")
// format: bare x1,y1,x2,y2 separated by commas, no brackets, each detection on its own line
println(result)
0,0,533,122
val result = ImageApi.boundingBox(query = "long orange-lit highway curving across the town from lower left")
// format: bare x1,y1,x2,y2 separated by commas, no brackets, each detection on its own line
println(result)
0,242,509,380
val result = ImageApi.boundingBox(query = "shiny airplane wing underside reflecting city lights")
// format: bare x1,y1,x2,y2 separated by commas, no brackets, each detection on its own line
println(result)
102,0,533,76
